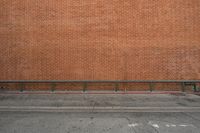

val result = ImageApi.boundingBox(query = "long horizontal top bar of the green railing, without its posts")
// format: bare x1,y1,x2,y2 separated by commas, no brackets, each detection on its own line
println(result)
0,80,200,83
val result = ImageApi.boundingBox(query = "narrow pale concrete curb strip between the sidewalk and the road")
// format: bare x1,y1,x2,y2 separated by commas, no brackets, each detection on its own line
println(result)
0,106,200,113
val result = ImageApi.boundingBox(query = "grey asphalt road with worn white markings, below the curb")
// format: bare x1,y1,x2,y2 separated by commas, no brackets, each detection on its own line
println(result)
0,112,200,133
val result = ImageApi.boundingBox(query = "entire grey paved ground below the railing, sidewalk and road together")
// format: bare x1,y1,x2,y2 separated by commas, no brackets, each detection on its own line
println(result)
0,94,200,133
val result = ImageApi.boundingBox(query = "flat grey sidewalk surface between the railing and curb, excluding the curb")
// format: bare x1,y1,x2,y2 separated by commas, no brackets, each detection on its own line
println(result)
0,93,200,107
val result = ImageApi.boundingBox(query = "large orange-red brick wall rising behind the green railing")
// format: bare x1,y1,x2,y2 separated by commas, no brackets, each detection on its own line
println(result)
0,0,200,80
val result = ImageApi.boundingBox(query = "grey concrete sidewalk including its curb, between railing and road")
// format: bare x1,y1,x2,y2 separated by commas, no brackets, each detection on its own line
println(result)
0,93,200,112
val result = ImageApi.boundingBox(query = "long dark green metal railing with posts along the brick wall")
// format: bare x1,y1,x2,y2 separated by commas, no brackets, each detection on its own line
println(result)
0,80,200,92
